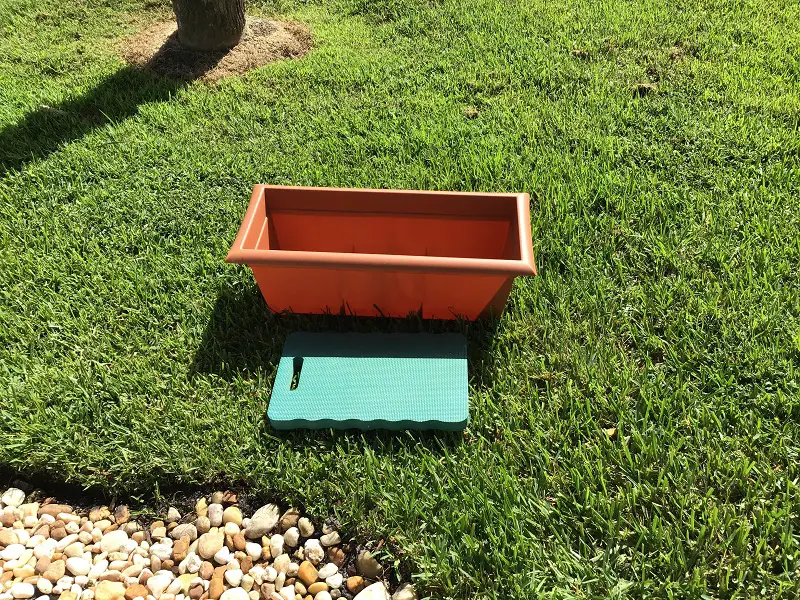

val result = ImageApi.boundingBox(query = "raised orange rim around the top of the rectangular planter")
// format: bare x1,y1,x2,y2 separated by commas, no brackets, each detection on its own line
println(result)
225,184,537,275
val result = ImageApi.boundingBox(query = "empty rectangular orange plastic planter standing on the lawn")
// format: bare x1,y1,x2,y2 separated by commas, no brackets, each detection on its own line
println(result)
226,185,536,319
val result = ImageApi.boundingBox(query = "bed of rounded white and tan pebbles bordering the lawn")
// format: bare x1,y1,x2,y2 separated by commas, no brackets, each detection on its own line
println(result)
0,488,416,600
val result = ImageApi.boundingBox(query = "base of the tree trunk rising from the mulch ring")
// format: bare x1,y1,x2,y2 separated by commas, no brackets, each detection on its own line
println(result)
172,0,244,50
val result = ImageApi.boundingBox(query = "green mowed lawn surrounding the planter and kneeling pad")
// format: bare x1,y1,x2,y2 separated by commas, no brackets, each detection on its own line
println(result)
0,0,800,599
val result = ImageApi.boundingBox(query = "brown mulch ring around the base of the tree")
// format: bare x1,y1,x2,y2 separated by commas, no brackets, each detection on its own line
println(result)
122,17,312,82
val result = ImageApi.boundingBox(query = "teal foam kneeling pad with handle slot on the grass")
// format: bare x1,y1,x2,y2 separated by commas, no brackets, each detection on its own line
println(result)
267,332,469,431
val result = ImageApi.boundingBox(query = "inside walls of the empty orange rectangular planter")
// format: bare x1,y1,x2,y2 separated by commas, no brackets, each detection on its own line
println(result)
255,188,520,260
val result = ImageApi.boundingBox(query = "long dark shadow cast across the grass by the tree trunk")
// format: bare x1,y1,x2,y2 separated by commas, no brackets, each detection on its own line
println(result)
0,35,227,176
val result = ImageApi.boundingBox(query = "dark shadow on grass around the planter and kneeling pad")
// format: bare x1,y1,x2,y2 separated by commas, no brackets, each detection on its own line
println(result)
190,286,499,446
